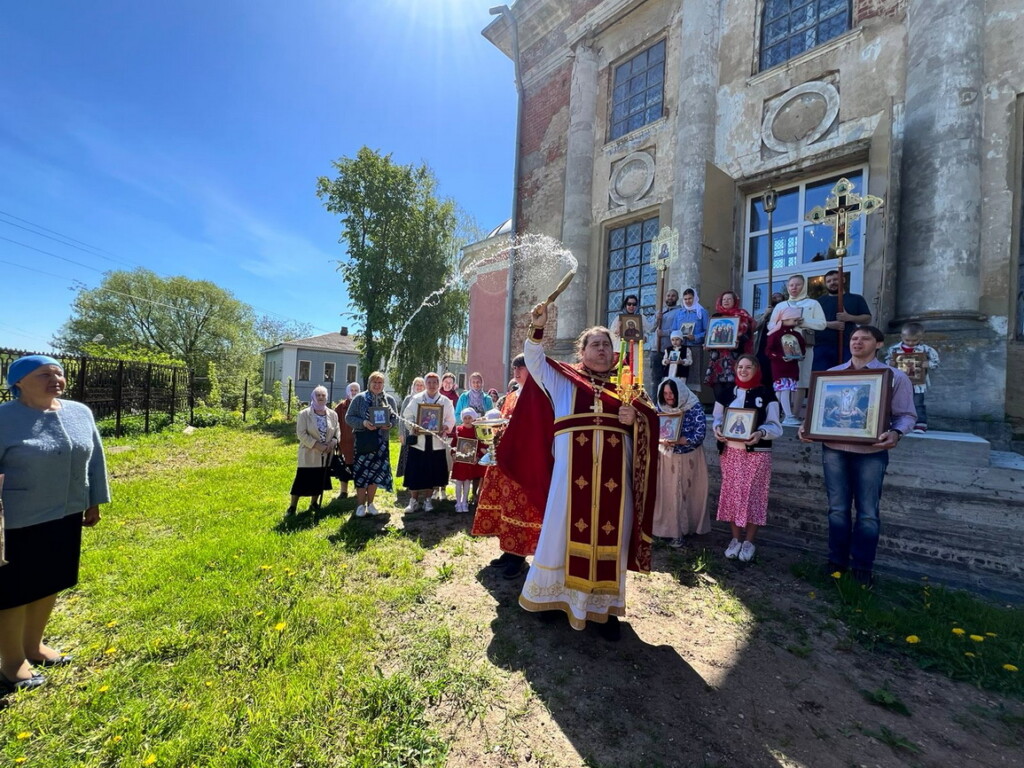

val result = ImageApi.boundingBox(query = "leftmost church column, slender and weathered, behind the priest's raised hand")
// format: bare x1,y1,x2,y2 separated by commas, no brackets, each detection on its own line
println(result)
556,42,597,347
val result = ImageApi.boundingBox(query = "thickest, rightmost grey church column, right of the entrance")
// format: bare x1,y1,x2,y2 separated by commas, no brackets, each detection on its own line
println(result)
897,0,984,327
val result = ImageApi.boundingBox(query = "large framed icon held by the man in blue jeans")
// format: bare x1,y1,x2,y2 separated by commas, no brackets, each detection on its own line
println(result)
804,368,893,442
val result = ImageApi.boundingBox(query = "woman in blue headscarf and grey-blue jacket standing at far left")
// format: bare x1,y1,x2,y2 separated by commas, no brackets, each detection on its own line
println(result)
0,354,111,695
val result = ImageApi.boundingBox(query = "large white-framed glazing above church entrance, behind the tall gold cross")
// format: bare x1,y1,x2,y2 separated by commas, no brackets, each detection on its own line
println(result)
743,166,867,314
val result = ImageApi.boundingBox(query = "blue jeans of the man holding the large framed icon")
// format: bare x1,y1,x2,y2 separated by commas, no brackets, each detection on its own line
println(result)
821,445,889,571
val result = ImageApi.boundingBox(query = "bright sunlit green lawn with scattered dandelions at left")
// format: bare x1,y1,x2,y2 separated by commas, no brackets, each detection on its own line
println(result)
0,427,471,768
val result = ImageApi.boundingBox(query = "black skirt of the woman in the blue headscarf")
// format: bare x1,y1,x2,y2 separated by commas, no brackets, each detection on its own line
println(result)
0,512,82,610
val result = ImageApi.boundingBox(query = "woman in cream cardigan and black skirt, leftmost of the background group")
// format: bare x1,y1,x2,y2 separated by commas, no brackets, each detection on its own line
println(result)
286,386,341,515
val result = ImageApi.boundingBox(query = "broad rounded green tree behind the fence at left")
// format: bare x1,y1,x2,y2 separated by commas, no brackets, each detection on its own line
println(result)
53,268,259,393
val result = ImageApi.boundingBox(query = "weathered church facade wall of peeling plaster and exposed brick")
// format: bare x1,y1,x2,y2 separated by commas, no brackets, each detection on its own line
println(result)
488,0,1024,425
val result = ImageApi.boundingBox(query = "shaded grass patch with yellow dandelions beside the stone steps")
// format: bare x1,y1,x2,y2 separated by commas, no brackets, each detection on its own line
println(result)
794,562,1024,697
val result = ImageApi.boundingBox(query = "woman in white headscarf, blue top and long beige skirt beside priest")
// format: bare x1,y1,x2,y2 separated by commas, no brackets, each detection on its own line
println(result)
652,379,711,549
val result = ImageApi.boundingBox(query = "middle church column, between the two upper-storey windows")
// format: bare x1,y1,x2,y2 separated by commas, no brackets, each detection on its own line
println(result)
669,0,731,292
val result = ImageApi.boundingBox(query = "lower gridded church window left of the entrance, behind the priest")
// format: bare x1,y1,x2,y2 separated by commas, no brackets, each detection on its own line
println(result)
605,216,658,325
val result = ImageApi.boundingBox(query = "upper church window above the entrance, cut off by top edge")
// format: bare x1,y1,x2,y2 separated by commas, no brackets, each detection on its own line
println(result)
761,0,851,70
